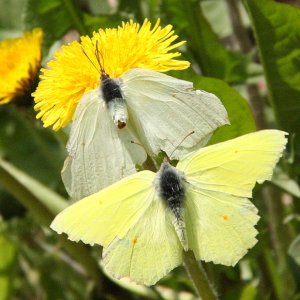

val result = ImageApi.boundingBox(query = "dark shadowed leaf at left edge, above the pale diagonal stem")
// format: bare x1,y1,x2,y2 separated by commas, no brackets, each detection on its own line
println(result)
0,105,66,192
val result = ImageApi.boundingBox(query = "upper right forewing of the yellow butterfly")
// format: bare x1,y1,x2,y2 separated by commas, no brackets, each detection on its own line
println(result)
177,130,287,197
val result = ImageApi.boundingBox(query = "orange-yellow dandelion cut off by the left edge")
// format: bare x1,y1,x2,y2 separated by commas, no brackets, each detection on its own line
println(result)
0,28,43,104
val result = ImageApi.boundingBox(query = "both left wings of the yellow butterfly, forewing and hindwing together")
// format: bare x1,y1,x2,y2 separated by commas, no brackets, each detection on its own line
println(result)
50,171,182,285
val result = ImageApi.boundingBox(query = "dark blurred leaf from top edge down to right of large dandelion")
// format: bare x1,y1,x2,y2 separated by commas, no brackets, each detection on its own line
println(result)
163,0,248,83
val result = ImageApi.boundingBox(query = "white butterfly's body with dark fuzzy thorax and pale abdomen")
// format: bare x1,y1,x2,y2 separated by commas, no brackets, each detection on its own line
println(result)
100,72,128,129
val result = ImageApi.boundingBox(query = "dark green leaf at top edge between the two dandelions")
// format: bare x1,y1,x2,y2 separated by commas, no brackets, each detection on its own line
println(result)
24,0,87,48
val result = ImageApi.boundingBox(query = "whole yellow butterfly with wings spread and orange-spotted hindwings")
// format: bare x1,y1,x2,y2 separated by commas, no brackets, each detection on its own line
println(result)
51,130,287,285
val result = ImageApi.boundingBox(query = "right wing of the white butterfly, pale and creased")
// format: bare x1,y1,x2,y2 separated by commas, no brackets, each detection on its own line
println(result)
121,69,229,158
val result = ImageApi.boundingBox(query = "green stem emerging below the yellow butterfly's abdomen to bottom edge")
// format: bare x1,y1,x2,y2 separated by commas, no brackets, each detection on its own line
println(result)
183,251,218,300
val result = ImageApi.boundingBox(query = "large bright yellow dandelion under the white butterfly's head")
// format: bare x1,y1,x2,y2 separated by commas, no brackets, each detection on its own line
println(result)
33,19,190,130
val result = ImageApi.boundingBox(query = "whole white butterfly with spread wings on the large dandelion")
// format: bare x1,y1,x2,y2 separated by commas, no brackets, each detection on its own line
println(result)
62,54,229,200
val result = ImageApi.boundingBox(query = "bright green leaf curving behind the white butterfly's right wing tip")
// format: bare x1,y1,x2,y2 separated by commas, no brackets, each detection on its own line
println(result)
194,76,256,144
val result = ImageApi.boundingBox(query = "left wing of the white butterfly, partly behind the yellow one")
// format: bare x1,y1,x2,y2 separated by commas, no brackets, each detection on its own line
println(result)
62,90,146,200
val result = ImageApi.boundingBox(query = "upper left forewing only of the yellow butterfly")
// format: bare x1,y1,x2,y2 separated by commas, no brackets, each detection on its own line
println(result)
50,171,155,246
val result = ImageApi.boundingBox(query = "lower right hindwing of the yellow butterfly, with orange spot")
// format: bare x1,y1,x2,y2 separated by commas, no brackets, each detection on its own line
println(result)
185,188,259,266
